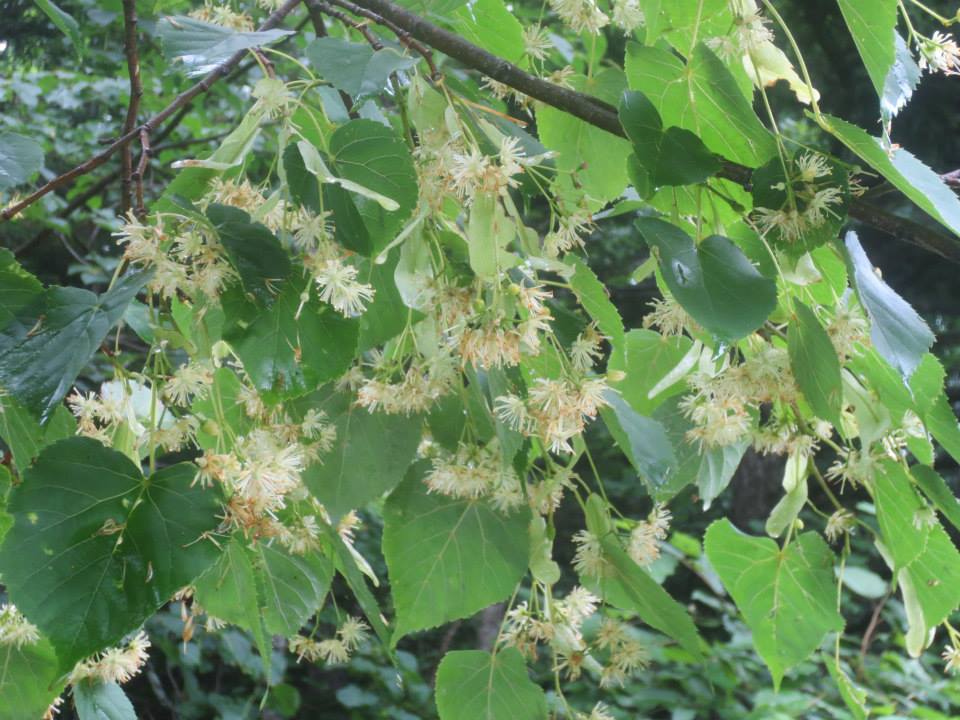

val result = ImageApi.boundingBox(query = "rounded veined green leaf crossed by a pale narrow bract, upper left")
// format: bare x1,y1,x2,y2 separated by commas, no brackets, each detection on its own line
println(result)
330,120,419,254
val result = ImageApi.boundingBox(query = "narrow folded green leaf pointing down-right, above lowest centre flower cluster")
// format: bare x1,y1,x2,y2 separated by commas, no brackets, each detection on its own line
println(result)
581,495,703,659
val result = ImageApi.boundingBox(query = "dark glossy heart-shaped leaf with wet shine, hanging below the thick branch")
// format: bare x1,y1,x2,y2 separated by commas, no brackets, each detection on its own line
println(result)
636,217,777,342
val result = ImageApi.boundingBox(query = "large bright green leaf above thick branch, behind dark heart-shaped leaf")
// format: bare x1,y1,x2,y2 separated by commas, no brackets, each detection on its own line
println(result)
625,42,777,167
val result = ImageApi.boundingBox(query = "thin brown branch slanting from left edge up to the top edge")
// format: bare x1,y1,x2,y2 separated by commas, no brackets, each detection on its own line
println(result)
0,0,302,220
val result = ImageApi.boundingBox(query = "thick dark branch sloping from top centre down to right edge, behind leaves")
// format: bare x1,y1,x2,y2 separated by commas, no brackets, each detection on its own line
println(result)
348,0,960,263
